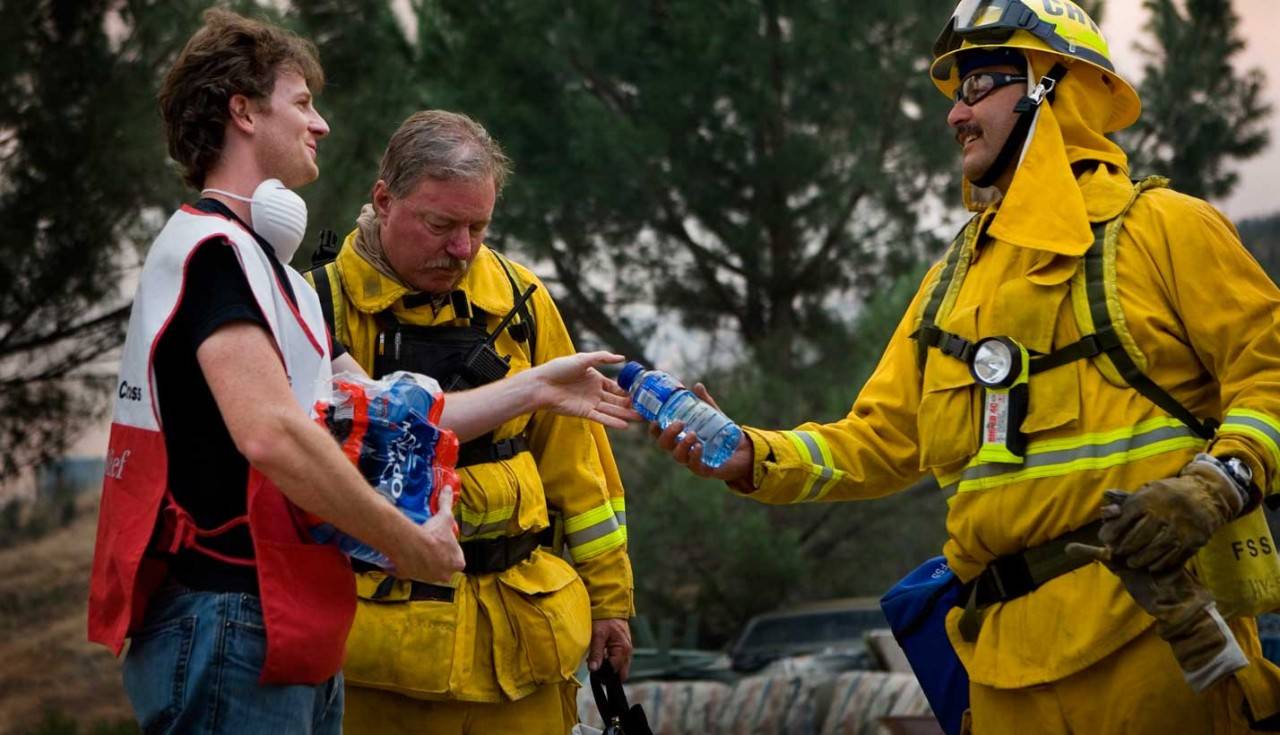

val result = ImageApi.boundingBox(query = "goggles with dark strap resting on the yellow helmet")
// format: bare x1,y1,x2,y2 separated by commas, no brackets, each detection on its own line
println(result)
933,0,1115,73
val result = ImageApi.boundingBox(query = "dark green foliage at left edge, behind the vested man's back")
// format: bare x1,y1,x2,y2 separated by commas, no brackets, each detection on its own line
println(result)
0,0,209,478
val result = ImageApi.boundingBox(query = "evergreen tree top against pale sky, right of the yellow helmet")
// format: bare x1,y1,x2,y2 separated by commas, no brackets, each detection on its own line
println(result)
1119,0,1271,197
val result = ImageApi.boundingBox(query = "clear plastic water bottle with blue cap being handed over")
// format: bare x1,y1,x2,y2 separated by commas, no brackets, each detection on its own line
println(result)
618,362,742,467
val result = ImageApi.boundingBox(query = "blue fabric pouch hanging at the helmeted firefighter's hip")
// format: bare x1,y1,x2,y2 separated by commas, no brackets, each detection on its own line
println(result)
881,556,969,735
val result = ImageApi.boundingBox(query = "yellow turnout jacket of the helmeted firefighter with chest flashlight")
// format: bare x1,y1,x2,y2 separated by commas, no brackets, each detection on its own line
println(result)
746,54,1280,688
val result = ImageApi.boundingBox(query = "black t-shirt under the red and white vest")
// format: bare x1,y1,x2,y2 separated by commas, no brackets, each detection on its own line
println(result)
155,198,337,594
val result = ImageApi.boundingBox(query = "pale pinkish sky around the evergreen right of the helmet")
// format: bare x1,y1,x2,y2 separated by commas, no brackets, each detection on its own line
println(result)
1102,0,1280,219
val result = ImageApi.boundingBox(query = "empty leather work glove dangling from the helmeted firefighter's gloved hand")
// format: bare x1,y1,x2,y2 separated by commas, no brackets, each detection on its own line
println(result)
1066,542,1249,693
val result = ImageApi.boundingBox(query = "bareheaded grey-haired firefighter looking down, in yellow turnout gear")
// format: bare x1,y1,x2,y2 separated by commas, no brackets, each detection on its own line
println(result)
308,111,634,735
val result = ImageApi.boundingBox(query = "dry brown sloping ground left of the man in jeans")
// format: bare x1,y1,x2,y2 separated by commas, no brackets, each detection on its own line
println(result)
0,506,131,735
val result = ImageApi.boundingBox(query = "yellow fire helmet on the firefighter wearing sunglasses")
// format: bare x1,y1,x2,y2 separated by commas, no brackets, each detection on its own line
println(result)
929,0,1142,133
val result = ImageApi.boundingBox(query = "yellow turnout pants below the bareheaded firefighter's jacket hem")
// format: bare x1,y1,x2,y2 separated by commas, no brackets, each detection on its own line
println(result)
342,681,577,735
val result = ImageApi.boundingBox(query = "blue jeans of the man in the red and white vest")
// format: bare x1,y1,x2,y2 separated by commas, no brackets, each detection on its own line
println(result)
124,585,343,735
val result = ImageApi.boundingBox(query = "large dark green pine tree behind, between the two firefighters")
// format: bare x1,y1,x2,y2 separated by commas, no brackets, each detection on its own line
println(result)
366,0,954,368
